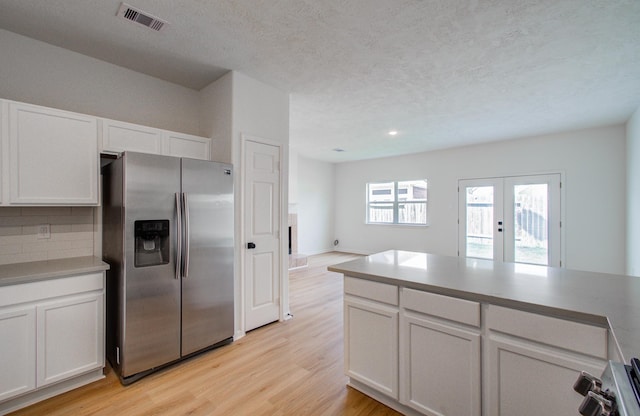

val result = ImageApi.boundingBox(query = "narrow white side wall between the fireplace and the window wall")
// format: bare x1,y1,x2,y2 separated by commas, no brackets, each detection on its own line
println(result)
296,156,335,255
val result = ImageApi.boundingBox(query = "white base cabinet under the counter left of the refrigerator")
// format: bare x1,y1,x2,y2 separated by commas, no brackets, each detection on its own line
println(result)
0,272,105,414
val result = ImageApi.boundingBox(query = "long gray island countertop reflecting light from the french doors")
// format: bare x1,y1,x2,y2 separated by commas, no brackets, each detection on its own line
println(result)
328,250,640,362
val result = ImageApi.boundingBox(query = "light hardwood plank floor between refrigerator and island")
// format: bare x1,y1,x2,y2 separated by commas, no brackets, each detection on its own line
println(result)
8,253,400,416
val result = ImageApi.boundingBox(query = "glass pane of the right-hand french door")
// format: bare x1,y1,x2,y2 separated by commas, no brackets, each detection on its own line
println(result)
513,183,549,266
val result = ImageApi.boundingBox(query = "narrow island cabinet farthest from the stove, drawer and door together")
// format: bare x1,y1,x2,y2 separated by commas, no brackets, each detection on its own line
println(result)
344,277,400,400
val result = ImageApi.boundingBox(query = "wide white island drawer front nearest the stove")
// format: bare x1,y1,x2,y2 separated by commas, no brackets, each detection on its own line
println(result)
486,305,608,360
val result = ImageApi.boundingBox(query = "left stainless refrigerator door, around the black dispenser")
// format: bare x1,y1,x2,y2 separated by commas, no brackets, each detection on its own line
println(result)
120,153,180,377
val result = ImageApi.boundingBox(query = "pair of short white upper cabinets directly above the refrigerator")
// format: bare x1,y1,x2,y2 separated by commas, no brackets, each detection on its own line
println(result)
101,119,211,160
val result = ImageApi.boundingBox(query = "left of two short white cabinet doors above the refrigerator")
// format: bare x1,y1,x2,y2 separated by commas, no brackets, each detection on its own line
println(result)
102,120,162,155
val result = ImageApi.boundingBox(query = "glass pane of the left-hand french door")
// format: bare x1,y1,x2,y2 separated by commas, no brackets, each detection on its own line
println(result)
466,186,494,259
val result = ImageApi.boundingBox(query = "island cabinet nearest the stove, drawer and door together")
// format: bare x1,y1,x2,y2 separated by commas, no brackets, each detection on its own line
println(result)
485,305,609,416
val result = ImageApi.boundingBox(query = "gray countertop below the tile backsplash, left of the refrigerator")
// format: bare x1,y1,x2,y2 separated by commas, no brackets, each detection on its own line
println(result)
0,256,109,286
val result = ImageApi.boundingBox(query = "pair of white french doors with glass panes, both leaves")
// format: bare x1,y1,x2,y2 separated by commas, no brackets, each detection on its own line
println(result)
458,174,561,267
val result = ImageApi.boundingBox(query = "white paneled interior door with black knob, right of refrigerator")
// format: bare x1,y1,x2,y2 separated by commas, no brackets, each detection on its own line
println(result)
244,140,281,331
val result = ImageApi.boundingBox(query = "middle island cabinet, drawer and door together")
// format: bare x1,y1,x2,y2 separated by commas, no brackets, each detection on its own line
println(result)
400,288,481,416
